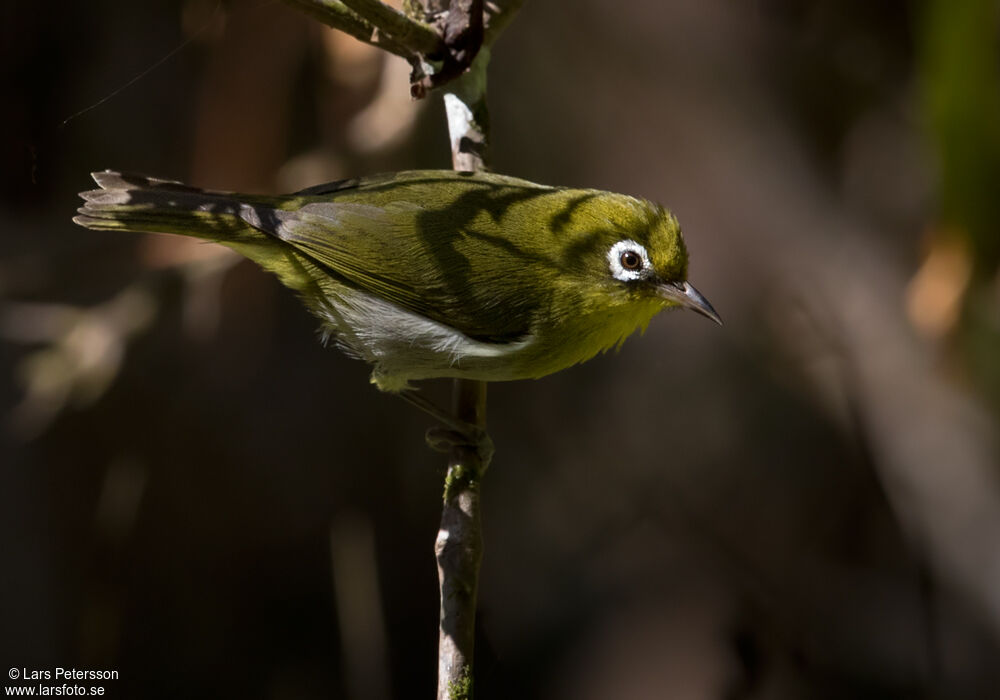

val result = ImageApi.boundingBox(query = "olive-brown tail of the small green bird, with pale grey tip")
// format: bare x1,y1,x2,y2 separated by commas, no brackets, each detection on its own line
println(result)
73,170,266,244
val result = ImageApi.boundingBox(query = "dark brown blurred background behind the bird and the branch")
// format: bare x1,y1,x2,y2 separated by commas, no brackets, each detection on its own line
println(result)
0,0,1000,700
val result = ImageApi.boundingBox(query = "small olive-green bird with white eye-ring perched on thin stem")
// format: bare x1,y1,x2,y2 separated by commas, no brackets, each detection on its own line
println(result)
74,170,719,391
